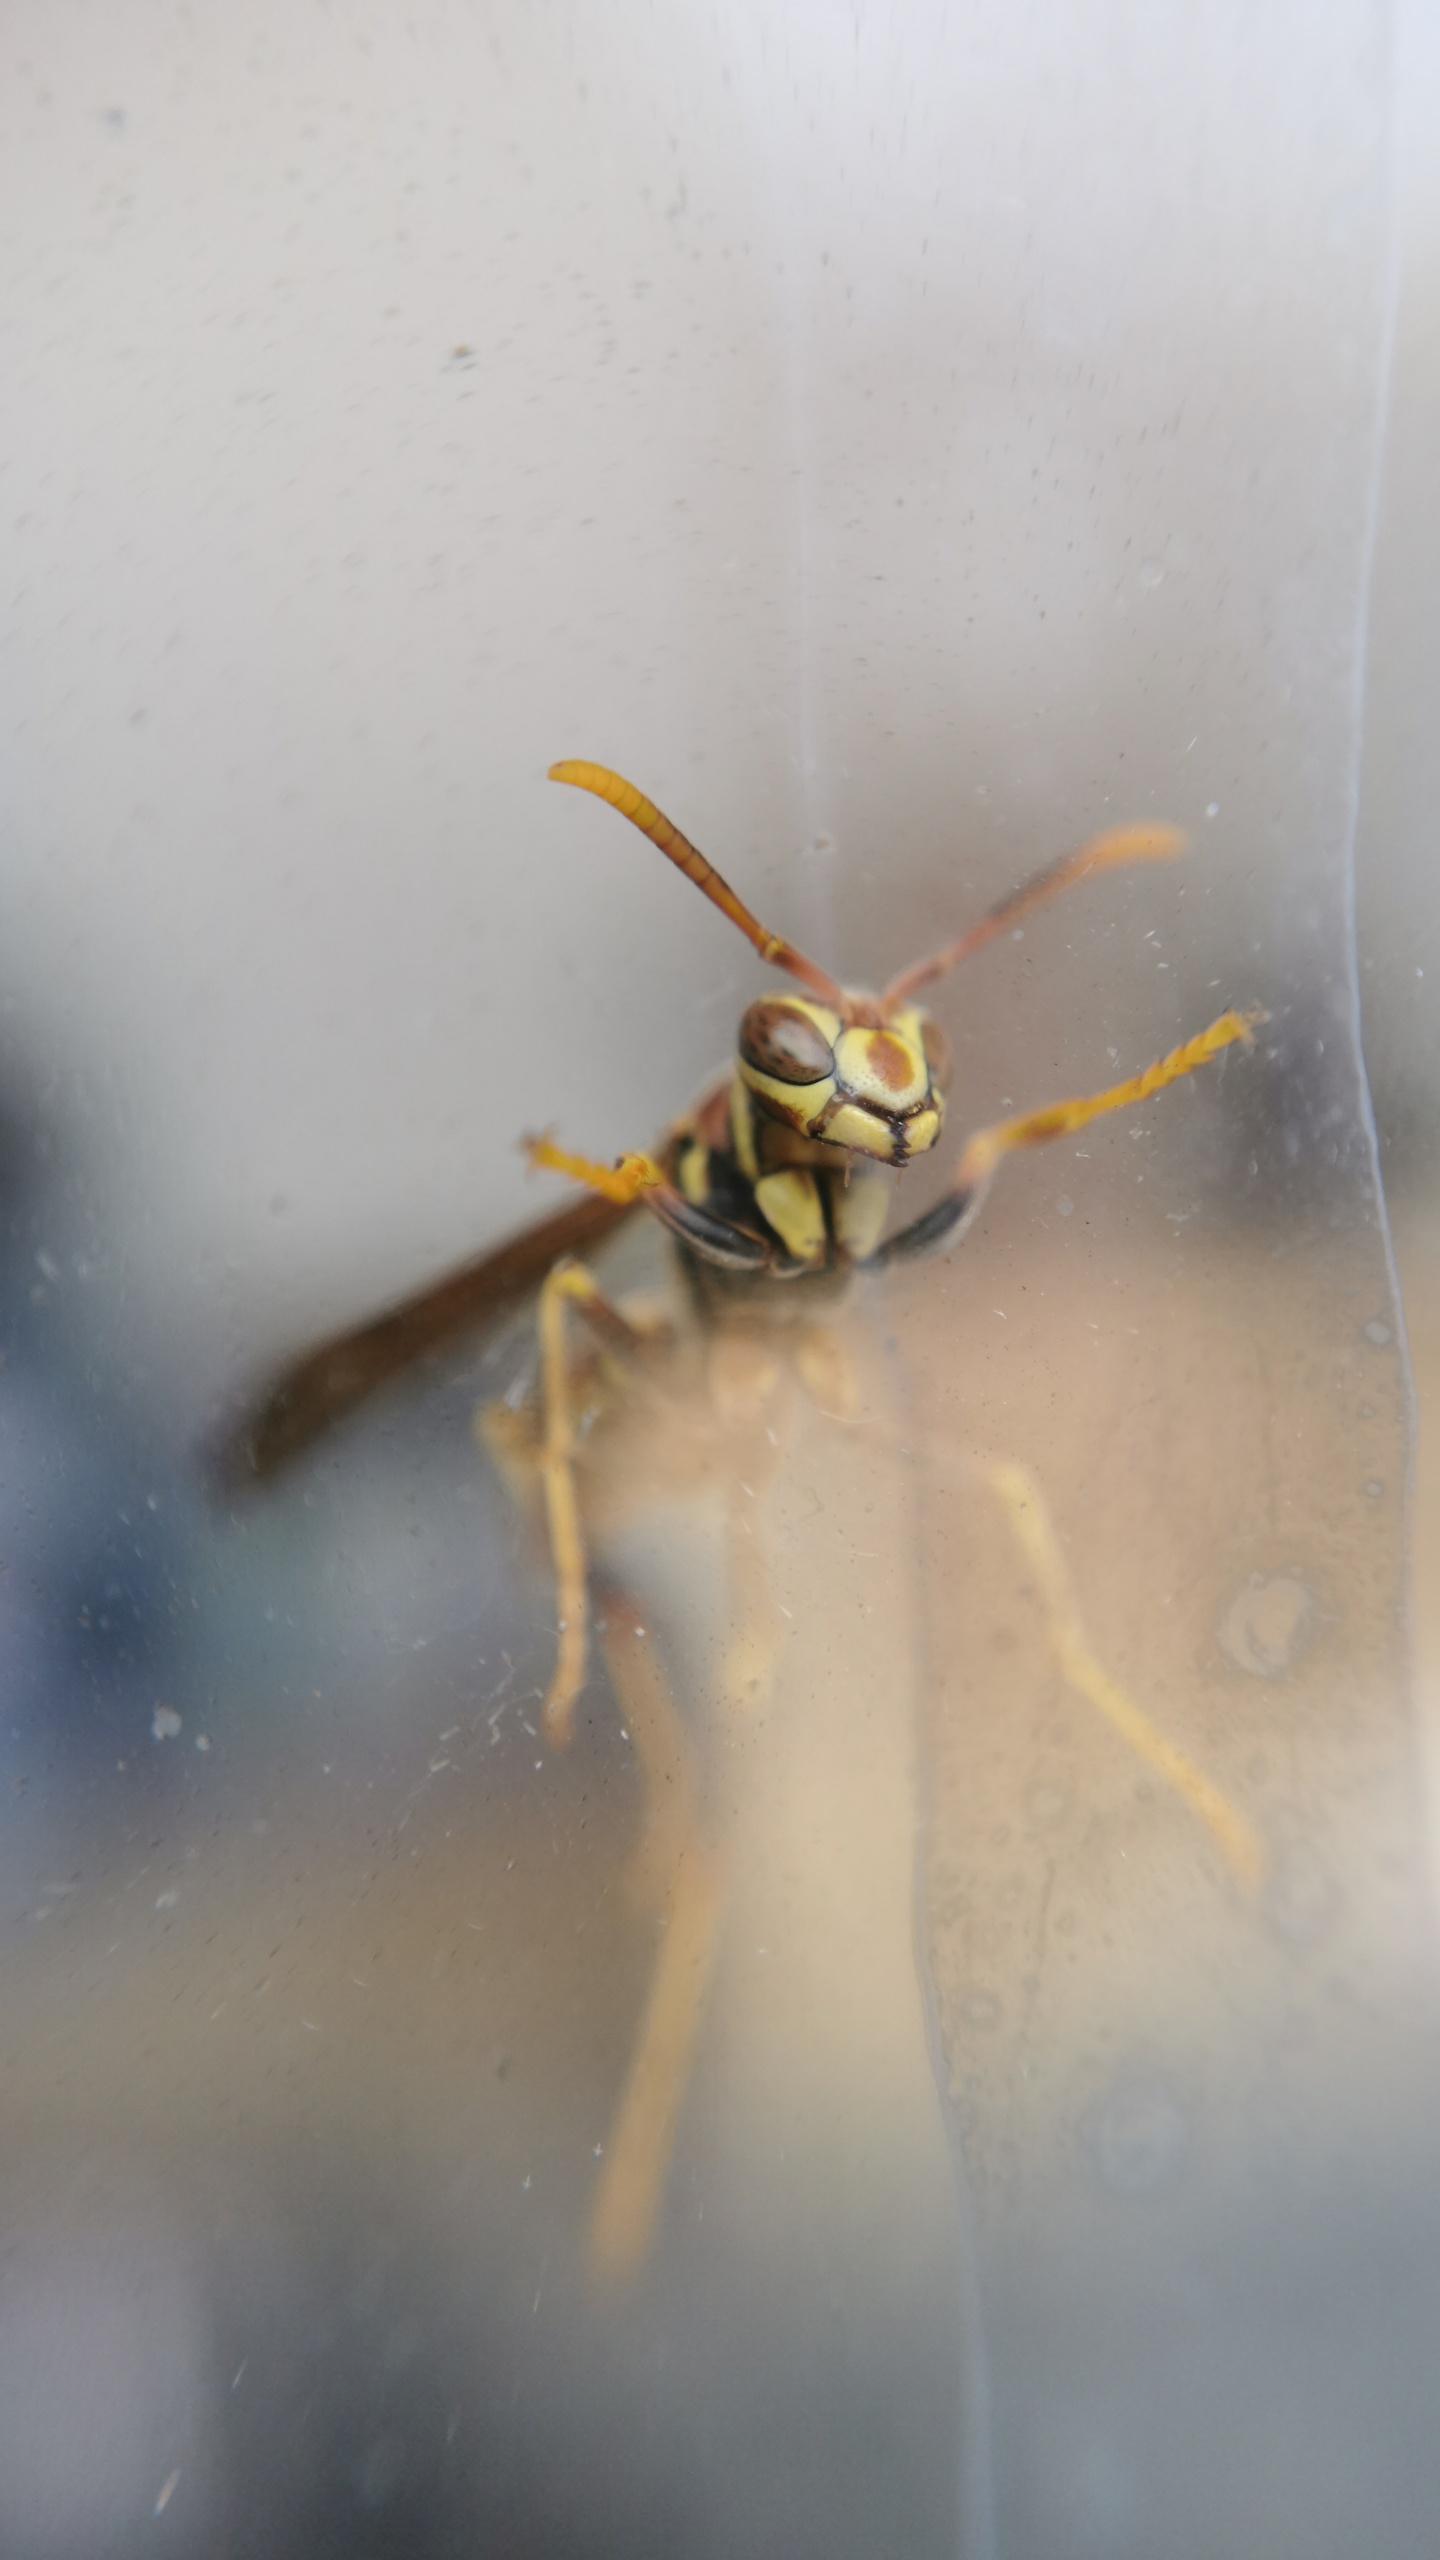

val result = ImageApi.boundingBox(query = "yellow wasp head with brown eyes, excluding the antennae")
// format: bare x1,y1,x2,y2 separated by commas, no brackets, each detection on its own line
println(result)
738,996,948,1170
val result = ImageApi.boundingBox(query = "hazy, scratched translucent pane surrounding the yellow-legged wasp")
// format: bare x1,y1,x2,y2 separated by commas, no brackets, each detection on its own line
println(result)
0,0,1440,2560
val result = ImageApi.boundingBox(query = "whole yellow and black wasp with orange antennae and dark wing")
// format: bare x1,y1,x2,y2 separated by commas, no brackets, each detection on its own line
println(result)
231,760,1263,2273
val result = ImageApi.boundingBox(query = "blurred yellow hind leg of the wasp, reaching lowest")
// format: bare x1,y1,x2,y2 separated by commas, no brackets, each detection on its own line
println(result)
589,1592,723,2278
